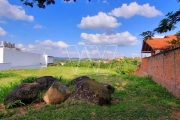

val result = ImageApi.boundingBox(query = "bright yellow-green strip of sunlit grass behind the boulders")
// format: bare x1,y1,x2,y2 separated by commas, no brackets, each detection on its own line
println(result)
0,66,117,85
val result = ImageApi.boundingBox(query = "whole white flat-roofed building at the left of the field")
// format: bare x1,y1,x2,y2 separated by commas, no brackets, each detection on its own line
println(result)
0,41,53,70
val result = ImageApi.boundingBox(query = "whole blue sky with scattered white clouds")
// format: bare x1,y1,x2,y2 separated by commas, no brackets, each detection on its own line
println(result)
0,0,180,59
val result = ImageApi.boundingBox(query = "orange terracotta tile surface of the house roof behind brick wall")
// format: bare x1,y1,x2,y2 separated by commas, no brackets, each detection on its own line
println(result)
145,35,176,50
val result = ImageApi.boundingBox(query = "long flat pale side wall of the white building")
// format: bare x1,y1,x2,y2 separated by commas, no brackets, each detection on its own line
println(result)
3,48,42,67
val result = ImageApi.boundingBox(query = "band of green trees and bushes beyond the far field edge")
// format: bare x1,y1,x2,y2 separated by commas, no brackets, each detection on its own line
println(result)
48,57,140,75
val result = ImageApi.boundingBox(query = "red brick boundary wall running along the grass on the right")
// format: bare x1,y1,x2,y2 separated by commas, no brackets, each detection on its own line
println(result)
136,49,180,98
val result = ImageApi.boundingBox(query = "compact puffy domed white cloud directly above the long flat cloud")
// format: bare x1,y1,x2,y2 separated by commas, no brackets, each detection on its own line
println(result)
78,12,121,29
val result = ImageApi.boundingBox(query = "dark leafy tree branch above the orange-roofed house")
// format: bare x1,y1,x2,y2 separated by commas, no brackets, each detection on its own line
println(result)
140,0,180,40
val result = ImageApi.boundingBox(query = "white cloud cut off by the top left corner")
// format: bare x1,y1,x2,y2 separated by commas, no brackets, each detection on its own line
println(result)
0,0,34,21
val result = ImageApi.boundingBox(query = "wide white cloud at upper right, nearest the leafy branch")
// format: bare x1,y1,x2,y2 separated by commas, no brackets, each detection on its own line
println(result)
109,2,162,18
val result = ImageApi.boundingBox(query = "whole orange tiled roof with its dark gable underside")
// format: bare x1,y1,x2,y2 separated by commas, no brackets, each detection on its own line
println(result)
141,35,177,53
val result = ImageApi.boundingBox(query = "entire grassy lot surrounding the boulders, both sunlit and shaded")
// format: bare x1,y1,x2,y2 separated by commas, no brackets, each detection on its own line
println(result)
0,67,180,120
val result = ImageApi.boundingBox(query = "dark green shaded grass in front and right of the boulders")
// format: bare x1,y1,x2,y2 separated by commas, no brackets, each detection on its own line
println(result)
1,75,180,120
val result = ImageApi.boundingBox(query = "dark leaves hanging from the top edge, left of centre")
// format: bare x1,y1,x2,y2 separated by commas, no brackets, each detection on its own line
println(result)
20,0,91,8
